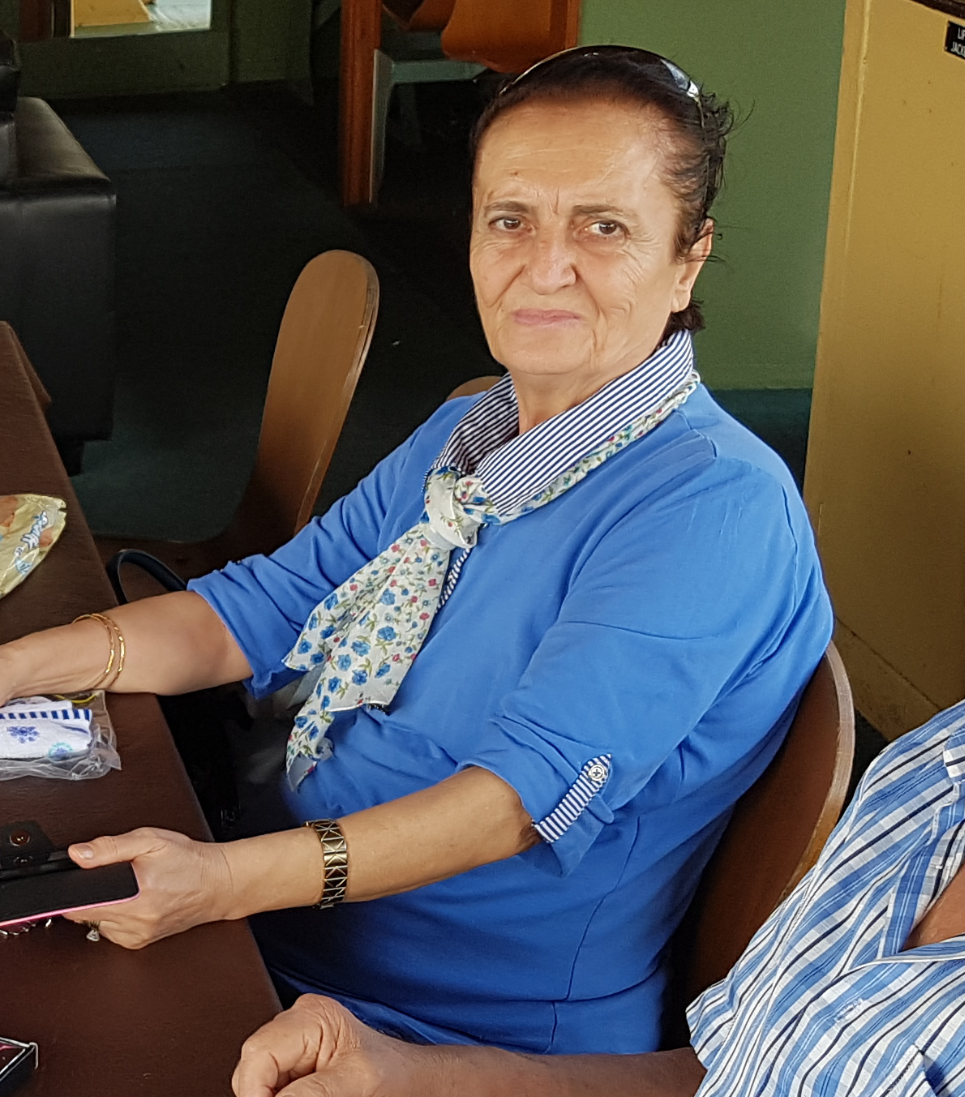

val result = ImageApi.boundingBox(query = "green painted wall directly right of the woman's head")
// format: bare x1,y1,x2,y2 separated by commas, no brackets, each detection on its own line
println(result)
580,0,844,388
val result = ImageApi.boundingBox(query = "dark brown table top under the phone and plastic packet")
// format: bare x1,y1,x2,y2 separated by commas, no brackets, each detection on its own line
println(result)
0,324,279,1097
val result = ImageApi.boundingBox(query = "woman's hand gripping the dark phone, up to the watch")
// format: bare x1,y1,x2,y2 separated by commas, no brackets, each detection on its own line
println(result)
66,827,232,949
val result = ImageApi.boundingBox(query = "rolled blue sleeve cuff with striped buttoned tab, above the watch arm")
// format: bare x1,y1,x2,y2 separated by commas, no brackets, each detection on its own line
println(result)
459,726,613,875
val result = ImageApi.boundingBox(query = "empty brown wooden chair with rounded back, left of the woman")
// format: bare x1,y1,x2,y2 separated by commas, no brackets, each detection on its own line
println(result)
97,251,378,597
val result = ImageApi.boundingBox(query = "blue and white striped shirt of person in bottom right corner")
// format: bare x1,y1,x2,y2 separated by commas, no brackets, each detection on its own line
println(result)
689,702,965,1097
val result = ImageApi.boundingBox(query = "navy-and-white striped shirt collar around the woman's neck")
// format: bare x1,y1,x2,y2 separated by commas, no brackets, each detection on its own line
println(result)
433,331,694,512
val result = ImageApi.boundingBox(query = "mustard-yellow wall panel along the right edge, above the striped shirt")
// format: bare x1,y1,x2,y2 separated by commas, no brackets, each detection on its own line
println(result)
805,0,965,735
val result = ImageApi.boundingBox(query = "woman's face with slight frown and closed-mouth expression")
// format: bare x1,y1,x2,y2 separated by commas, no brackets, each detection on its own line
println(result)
469,101,711,403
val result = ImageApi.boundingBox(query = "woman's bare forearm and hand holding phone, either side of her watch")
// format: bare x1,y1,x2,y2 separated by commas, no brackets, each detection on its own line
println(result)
54,766,538,949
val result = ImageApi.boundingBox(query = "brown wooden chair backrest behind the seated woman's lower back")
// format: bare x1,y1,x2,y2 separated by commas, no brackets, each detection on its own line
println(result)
674,644,854,1005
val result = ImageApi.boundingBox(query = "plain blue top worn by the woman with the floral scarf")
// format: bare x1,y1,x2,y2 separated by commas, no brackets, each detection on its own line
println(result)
192,387,831,1053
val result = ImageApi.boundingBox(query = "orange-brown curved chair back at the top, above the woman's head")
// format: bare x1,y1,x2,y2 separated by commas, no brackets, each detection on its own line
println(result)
442,0,580,72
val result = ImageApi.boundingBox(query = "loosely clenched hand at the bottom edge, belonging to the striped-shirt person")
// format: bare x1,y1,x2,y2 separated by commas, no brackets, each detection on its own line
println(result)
231,994,433,1097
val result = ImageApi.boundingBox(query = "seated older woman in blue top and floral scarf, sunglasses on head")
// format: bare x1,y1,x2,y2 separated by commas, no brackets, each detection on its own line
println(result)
0,47,831,1052
